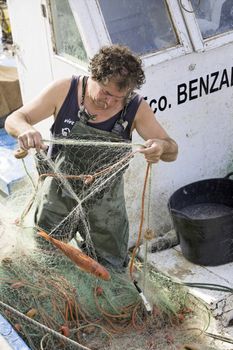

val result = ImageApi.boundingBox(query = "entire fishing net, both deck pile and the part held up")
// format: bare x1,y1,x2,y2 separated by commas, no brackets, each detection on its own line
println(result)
0,139,219,350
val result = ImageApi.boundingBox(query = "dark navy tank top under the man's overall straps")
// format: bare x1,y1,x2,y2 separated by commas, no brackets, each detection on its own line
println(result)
49,76,143,155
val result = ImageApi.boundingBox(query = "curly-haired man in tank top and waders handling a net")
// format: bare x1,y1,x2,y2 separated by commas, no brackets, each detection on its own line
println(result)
5,45,178,268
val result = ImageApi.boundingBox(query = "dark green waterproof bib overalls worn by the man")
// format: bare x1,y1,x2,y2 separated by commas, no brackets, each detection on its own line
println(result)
35,76,140,268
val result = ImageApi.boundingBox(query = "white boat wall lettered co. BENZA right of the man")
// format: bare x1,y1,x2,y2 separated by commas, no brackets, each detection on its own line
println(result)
127,44,233,243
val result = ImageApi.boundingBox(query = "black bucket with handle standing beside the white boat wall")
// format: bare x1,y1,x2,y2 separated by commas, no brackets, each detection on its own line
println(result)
168,173,233,266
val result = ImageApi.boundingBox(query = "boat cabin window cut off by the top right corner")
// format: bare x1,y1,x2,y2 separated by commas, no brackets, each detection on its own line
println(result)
191,0,233,39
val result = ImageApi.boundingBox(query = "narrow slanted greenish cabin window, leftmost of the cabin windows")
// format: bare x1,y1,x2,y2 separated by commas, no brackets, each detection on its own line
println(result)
49,0,87,62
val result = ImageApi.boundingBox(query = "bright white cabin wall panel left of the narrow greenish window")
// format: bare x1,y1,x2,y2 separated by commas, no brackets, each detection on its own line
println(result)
7,0,52,102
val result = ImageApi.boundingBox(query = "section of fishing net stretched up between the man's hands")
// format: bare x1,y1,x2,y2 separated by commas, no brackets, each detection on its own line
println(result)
22,135,134,245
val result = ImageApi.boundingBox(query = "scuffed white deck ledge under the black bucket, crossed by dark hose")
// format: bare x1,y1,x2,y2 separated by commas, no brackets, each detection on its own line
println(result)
145,246,233,350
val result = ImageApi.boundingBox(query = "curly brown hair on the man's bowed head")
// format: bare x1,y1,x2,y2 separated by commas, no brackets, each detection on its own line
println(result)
88,45,145,91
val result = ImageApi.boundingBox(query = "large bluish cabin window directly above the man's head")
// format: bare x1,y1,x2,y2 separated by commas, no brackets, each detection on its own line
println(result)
98,0,179,55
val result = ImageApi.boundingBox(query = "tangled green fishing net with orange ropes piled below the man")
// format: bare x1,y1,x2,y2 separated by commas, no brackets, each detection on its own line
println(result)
0,250,211,349
